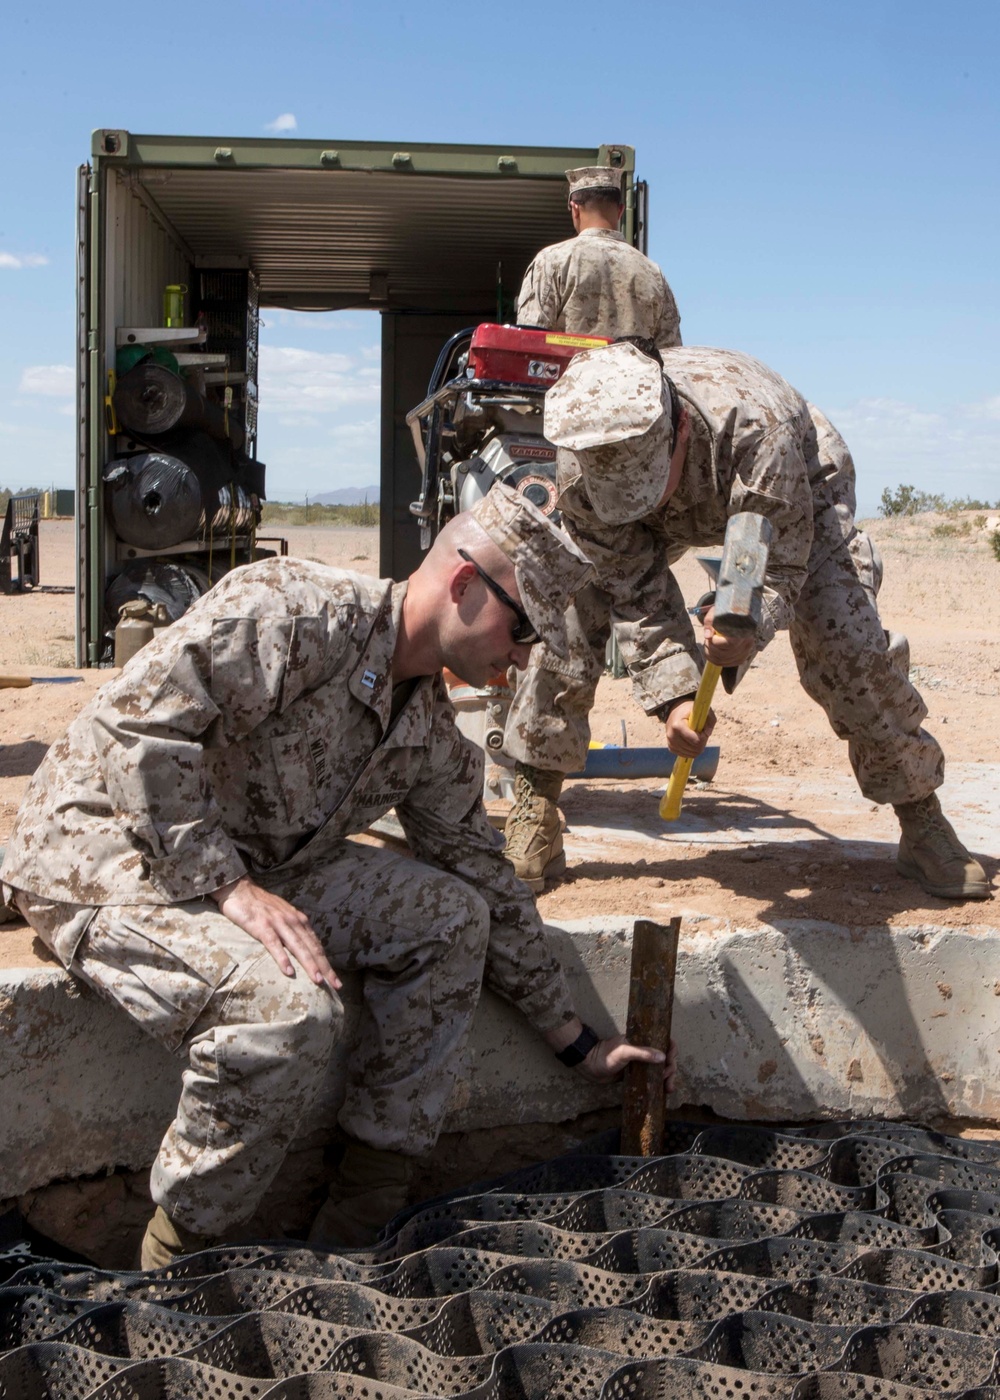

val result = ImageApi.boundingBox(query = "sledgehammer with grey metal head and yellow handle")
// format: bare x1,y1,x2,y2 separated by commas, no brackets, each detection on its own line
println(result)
660,511,772,822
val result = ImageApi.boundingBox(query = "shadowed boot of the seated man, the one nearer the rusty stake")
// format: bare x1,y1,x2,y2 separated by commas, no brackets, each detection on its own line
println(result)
308,1138,415,1250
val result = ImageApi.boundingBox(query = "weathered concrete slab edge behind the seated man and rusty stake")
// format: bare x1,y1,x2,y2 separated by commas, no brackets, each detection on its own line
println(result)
0,913,1000,1198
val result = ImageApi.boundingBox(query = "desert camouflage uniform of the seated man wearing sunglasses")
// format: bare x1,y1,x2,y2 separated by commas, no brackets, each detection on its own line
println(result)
3,560,573,1235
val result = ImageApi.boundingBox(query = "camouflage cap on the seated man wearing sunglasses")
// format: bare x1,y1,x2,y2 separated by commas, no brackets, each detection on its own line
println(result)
469,482,594,657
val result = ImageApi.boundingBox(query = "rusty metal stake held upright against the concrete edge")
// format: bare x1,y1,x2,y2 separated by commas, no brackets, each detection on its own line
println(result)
622,918,681,1156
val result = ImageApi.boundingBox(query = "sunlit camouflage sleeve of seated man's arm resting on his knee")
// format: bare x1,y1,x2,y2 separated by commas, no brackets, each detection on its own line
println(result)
92,582,352,902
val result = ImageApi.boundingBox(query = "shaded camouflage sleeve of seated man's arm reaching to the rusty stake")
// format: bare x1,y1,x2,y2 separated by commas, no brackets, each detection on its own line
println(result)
396,683,574,1032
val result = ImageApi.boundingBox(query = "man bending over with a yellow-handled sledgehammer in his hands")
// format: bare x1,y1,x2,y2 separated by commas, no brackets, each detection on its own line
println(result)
504,344,989,899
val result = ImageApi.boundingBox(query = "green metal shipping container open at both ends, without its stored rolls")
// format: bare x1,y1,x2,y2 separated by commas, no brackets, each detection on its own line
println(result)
77,129,646,665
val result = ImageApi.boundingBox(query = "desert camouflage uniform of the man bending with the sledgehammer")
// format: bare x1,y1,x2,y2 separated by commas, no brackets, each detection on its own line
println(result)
504,349,944,804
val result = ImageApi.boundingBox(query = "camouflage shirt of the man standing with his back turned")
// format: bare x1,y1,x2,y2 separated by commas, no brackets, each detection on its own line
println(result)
517,228,681,347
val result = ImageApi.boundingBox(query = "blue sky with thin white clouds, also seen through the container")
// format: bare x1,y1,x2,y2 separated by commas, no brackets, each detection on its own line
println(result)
0,0,1000,515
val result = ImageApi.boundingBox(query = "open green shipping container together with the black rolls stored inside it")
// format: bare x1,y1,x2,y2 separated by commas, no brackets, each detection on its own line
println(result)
76,129,646,666
